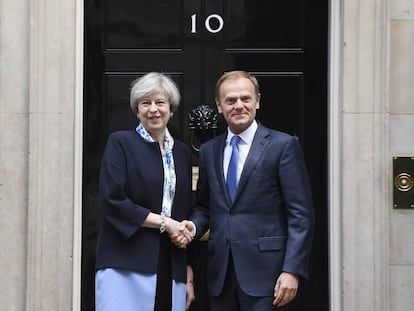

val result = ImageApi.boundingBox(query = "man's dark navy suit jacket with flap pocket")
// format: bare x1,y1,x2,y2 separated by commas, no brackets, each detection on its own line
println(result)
191,124,314,296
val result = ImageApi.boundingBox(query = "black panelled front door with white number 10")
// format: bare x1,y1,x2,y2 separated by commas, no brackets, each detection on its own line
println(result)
82,0,329,311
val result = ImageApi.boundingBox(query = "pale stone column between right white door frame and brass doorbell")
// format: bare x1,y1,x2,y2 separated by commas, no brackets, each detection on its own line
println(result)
341,0,392,311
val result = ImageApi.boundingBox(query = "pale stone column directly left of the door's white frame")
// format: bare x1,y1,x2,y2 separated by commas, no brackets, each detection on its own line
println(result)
26,0,76,310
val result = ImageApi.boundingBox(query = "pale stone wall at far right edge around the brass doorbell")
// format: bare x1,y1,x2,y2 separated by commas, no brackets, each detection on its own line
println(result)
389,0,414,311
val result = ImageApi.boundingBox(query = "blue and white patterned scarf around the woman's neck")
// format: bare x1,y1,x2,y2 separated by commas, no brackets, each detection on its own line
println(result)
135,123,176,217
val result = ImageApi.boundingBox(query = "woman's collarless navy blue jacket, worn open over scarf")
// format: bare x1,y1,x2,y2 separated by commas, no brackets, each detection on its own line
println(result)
96,131,192,282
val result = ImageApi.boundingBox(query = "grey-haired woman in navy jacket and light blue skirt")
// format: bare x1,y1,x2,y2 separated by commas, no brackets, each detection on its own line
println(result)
95,72,194,311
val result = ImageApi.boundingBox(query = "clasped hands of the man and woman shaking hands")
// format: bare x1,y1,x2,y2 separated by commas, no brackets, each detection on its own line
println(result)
165,218,196,248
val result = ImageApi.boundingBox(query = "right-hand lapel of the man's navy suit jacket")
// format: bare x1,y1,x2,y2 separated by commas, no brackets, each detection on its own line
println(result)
234,124,269,201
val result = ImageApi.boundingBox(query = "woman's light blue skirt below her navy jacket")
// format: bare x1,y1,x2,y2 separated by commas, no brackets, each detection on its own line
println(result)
95,268,186,311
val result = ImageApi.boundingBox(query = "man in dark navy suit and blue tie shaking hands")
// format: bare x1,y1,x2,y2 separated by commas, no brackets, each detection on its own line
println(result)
175,71,314,311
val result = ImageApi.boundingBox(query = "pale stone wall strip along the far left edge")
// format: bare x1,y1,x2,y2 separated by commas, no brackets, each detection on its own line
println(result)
0,0,30,311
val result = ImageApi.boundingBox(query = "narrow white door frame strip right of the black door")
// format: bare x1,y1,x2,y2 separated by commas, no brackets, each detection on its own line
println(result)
328,0,343,311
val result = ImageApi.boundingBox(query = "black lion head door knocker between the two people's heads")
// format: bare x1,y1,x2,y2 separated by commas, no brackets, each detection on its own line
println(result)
188,105,217,152
